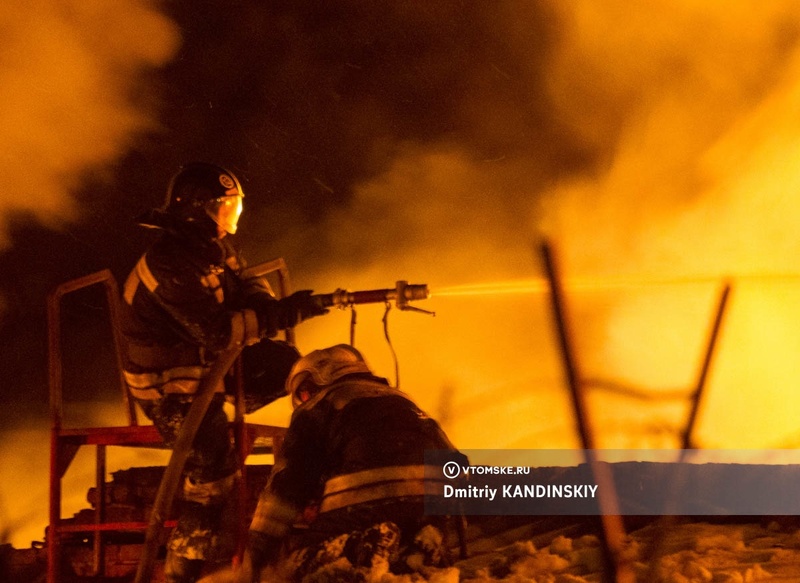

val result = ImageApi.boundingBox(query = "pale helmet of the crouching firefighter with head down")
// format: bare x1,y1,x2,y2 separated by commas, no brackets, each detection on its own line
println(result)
286,344,372,409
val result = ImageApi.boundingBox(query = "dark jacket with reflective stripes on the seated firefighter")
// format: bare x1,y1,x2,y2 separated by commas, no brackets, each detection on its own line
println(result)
121,220,279,400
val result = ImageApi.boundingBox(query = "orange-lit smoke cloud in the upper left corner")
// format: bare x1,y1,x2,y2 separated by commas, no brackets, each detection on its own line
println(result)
0,0,178,249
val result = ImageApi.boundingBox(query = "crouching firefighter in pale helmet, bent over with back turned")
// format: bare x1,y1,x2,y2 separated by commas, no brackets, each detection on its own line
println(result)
247,344,466,581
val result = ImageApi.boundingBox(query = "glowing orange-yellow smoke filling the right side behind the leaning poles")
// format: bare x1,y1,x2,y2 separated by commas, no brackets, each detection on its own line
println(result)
260,0,800,456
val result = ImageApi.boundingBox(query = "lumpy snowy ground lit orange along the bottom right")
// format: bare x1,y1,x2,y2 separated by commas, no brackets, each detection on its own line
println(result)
204,517,800,583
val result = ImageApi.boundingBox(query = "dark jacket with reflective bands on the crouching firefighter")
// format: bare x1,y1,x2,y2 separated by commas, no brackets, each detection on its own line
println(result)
250,374,462,539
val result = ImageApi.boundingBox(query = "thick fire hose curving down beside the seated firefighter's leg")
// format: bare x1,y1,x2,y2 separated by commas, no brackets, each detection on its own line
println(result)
134,347,241,583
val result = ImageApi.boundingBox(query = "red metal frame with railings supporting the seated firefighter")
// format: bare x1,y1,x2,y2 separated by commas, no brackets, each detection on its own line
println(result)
47,259,294,583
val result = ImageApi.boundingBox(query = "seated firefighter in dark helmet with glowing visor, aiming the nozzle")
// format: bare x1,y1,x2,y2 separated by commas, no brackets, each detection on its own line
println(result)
116,162,326,583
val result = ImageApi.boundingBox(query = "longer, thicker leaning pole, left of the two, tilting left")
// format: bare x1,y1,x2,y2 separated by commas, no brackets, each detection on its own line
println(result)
541,241,635,583
